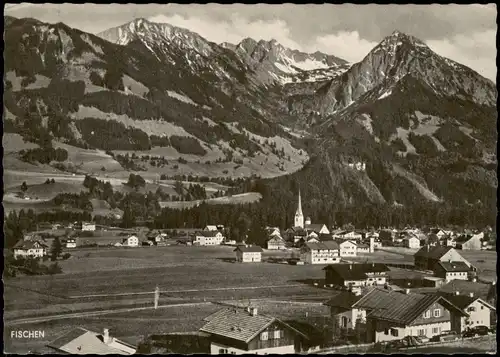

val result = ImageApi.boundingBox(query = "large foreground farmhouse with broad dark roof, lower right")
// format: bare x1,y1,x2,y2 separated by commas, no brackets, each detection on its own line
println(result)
362,289,467,342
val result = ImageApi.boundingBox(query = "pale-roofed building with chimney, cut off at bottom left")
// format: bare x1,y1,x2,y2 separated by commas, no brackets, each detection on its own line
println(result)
47,327,136,355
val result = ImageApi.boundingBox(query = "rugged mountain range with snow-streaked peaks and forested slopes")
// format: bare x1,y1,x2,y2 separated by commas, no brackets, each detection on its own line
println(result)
4,17,497,211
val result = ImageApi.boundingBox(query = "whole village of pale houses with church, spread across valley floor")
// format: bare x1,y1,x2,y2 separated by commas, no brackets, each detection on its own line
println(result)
5,192,496,354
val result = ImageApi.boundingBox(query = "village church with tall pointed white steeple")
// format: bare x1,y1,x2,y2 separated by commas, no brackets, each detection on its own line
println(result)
286,190,332,243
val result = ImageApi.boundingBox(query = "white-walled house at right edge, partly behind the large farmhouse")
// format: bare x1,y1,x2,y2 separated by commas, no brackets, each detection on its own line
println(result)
443,292,496,331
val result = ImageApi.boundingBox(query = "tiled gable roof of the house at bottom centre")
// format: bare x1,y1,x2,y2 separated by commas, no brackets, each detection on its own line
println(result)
200,307,303,343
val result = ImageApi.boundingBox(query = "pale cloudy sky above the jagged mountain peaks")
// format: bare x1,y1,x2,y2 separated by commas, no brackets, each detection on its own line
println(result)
5,3,497,81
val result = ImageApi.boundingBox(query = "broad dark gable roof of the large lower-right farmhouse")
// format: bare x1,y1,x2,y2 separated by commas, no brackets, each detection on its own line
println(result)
354,289,467,325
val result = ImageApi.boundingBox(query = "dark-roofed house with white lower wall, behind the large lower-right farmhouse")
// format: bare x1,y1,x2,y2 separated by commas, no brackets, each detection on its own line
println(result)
323,263,389,287
